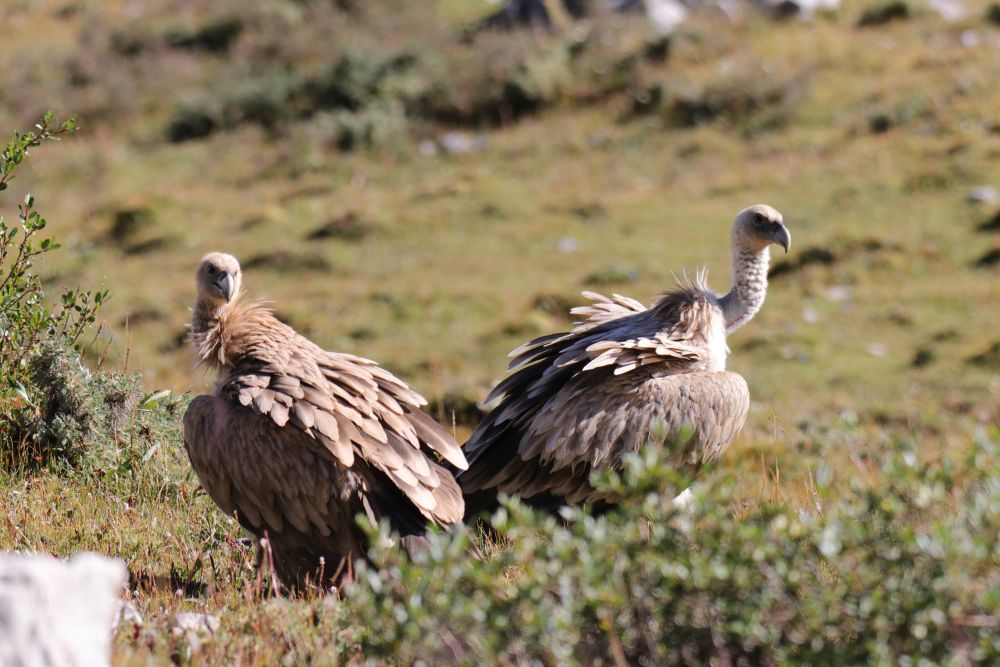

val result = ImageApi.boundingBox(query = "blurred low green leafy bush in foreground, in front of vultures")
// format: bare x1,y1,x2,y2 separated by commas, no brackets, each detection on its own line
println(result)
343,432,1000,665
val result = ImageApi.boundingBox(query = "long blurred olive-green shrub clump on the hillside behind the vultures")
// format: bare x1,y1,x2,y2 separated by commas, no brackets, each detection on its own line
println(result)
160,7,669,144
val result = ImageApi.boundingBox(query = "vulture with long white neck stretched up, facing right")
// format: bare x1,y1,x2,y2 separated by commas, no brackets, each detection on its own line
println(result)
458,205,791,516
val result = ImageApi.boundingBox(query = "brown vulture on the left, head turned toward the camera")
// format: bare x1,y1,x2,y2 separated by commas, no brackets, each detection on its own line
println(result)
184,253,466,587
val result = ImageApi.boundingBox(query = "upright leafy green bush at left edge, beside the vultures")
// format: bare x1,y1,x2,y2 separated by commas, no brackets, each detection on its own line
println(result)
0,113,119,464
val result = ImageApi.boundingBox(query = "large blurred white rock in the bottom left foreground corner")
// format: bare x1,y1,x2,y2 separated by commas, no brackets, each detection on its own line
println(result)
0,552,128,667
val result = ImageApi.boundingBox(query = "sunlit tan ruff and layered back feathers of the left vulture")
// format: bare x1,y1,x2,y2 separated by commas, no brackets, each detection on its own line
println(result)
195,303,465,524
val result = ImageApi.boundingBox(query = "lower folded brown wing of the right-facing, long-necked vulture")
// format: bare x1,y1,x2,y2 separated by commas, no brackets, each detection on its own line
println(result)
472,372,749,502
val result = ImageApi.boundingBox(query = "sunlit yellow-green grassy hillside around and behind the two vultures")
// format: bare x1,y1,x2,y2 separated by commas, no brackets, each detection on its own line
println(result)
0,0,1000,663
